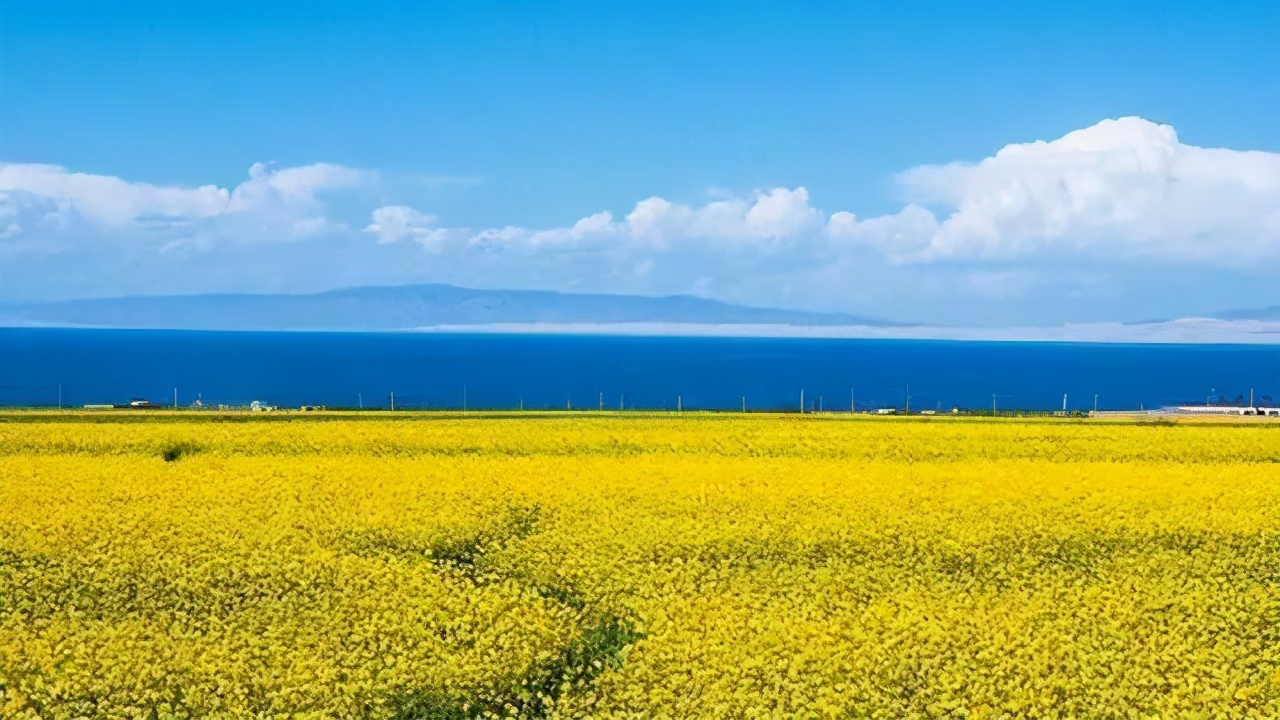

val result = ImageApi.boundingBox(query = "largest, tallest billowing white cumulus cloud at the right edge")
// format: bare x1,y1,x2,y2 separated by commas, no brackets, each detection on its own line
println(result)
828,118,1280,265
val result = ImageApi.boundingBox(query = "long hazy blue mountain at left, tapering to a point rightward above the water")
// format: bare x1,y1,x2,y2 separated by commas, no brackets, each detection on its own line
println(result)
0,284,901,331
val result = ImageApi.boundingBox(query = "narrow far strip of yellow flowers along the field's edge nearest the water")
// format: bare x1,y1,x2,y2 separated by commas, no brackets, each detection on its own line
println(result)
0,413,1280,464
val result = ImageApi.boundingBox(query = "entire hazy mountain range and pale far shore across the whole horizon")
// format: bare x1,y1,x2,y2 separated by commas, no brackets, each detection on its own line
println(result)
0,284,1280,345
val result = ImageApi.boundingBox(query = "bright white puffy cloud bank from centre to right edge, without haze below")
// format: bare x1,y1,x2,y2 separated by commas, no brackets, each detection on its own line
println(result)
414,118,1280,266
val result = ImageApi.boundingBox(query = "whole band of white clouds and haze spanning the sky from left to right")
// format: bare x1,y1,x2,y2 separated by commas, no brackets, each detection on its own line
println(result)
0,118,1280,318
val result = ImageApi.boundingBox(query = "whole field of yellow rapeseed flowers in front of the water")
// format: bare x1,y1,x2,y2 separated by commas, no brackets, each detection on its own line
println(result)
0,414,1280,719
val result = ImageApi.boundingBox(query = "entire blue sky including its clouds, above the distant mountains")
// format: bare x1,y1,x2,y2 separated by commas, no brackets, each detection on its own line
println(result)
0,0,1280,323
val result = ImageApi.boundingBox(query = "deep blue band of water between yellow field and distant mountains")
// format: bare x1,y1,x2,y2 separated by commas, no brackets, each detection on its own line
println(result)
0,328,1280,410
